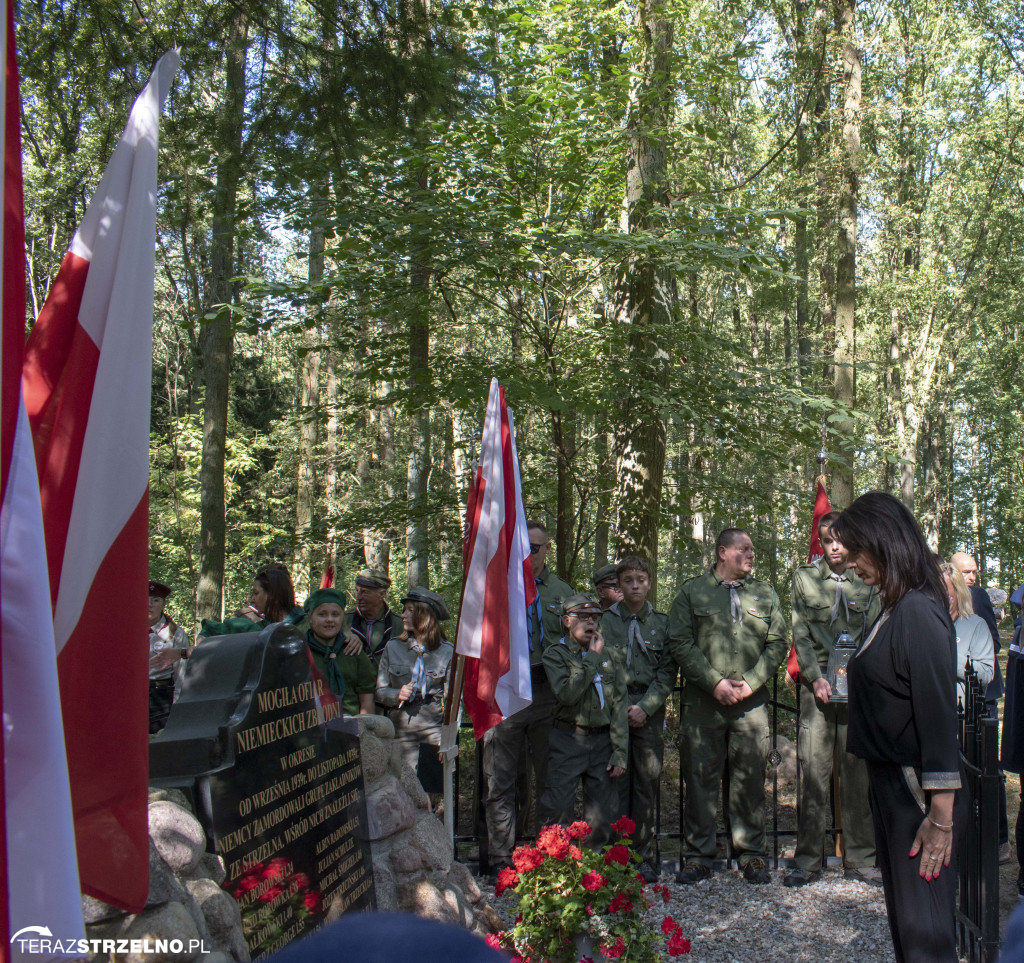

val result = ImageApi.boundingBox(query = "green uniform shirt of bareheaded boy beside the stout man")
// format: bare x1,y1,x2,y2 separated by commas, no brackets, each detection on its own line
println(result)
601,601,679,715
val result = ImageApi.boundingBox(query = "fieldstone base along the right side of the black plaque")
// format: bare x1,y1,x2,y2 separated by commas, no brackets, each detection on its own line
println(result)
356,715,501,934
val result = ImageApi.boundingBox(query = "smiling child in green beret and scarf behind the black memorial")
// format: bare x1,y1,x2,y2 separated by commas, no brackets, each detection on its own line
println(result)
302,588,377,715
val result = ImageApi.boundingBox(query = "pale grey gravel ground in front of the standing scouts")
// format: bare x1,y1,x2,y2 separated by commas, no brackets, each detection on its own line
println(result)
480,870,974,963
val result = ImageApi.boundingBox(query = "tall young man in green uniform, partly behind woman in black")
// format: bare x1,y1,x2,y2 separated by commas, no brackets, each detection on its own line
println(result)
783,511,882,886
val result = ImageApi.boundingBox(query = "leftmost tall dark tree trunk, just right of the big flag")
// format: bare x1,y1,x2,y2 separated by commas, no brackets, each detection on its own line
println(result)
196,8,249,619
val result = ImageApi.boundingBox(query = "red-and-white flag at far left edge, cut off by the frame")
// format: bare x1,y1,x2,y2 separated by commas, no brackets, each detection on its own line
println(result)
0,0,85,946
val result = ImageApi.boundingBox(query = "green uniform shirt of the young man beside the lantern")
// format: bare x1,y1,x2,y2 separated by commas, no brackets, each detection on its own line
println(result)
792,558,882,684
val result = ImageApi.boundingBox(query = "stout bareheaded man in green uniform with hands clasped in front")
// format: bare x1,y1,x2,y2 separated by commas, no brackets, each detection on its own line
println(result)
669,529,786,883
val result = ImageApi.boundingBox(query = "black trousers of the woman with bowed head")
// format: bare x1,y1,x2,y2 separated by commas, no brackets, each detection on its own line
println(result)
867,762,965,963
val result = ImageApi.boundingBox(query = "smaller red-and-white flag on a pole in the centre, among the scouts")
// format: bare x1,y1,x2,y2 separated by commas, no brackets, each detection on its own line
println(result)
456,378,537,739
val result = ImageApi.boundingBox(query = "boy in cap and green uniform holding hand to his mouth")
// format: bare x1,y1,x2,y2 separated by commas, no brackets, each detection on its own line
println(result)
539,595,629,848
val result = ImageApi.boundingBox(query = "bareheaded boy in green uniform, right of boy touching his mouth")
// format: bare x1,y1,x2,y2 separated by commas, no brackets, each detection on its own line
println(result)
601,555,679,883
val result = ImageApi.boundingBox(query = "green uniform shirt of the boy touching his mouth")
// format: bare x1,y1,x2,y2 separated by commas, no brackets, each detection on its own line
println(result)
544,638,630,768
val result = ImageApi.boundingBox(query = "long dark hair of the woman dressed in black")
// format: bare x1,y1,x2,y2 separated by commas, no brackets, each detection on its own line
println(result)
833,492,946,609
